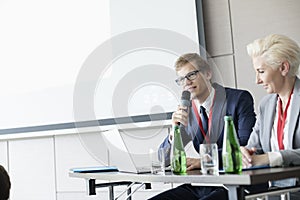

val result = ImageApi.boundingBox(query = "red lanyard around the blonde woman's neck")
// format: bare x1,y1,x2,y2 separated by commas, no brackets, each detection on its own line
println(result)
277,89,294,150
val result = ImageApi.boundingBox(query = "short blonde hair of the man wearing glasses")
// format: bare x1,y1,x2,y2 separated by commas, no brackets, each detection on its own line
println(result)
175,53,211,72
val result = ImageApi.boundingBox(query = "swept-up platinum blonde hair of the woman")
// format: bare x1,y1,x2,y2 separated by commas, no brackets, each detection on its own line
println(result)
247,34,300,76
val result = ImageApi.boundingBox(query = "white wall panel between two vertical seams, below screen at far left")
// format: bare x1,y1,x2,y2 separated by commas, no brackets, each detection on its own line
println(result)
8,138,56,200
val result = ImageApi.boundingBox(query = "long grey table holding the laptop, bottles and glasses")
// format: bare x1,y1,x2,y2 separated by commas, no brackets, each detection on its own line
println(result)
69,166,300,200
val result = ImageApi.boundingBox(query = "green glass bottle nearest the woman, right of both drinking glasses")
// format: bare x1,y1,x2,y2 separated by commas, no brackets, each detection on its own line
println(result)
222,116,243,174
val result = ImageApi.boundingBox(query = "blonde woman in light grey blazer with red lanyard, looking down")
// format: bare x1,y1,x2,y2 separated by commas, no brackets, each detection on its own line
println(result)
241,34,300,191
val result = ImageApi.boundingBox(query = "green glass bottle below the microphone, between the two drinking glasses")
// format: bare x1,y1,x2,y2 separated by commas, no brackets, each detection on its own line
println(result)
171,125,186,174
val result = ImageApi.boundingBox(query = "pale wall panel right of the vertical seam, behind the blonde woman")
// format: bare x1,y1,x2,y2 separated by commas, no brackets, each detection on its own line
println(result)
230,0,300,107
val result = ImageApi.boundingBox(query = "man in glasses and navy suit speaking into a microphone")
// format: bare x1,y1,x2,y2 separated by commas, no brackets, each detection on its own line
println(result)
151,53,255,200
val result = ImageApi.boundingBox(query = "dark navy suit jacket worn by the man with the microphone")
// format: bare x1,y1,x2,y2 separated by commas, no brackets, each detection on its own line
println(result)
160,83,256,168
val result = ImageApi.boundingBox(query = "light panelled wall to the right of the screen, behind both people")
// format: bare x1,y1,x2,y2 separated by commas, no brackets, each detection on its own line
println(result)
203,0,300,108
